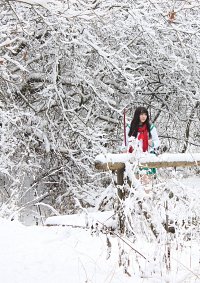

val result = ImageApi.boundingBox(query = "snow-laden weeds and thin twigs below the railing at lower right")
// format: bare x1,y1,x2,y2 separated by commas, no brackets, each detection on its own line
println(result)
92,165,200,283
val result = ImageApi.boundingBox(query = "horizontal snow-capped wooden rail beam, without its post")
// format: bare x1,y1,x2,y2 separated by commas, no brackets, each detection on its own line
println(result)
95,153,200,170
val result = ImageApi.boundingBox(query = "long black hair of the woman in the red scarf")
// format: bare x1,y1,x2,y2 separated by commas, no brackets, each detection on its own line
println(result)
128,106,151,138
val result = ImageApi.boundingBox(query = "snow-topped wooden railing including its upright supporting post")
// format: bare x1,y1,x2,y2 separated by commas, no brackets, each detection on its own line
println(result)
95,153,200,234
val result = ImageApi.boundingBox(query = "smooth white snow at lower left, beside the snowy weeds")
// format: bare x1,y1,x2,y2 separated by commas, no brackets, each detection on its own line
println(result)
0,216,136,283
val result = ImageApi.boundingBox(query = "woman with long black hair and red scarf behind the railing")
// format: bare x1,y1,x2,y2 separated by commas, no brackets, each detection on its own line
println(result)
128,107,160,193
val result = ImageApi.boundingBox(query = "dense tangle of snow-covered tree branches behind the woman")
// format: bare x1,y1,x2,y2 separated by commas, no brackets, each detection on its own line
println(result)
0,0,200,223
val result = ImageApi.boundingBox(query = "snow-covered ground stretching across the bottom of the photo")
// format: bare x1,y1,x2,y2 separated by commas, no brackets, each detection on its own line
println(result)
0,178,200,283
